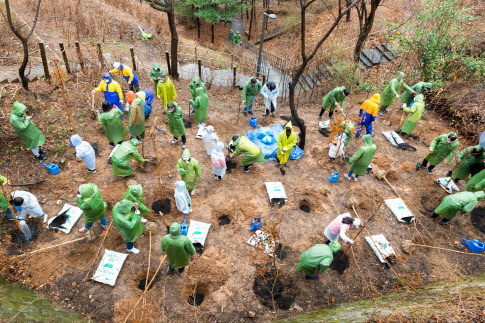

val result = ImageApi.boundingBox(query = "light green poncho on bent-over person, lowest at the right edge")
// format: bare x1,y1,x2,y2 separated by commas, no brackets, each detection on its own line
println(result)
434,191,485,220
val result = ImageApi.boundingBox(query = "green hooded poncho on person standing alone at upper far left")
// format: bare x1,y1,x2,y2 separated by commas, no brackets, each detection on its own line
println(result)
10,101,45,149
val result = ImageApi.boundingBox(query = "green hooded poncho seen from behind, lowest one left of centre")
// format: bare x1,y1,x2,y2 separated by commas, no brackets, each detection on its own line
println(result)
161,222,195,268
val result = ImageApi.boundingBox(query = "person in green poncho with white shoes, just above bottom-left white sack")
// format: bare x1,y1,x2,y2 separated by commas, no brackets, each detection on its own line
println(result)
112,200,145,254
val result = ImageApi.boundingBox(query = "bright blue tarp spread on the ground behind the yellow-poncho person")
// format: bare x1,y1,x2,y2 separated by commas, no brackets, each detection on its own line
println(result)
246,124,304,161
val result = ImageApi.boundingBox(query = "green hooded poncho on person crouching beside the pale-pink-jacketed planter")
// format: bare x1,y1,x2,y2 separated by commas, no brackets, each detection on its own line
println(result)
295,241,341,277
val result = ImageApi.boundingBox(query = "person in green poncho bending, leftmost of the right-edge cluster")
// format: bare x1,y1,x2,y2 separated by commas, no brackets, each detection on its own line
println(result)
420,131,460,174
